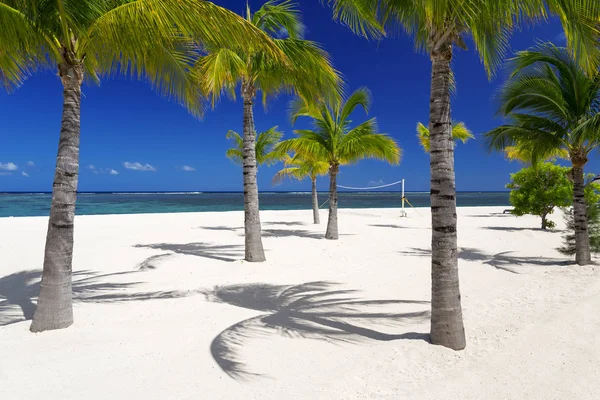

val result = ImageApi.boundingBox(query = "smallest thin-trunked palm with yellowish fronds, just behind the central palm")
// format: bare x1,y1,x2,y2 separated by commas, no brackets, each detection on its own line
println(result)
273,153,329,224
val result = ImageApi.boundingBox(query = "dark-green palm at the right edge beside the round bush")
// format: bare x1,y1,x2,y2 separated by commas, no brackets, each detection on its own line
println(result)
486,43,600,265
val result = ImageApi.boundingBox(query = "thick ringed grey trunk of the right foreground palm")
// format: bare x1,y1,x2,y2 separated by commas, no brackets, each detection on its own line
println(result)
429,45,466,350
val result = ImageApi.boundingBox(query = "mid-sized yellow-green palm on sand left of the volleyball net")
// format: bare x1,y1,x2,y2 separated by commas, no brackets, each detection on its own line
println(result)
277,88,400,240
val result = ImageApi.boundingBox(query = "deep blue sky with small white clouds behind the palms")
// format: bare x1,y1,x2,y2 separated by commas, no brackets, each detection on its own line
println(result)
0,0,600,191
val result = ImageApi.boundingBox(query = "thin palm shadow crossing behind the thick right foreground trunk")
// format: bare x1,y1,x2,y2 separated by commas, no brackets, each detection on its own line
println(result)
400,247,573,274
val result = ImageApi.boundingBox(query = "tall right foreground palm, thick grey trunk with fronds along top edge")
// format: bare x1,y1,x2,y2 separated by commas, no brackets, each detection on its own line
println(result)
328,0,600,350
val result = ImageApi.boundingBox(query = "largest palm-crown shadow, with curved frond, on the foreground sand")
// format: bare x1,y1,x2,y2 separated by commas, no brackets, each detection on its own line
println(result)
201,282,430,380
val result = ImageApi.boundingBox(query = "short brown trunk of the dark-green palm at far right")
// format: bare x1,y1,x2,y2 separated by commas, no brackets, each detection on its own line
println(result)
573,164,592,265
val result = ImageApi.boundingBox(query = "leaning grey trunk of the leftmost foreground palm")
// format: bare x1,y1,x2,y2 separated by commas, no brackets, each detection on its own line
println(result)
30,62,83,332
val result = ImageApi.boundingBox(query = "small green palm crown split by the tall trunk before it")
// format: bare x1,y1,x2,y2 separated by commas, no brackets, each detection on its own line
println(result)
225,126,283,165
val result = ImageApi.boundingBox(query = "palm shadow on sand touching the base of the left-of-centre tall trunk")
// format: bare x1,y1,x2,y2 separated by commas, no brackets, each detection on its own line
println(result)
133,242,244,262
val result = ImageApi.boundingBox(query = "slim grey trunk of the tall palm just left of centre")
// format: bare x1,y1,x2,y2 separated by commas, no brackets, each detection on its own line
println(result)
242,84,266,262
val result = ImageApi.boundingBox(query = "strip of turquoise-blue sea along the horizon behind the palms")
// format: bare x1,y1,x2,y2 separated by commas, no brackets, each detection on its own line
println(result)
0,192,509,217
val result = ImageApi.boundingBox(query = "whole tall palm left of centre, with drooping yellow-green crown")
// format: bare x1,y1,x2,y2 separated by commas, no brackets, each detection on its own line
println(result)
195,0,340,262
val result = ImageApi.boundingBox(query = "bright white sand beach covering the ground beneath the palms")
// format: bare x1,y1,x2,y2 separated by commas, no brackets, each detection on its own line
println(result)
0,207,600,400
